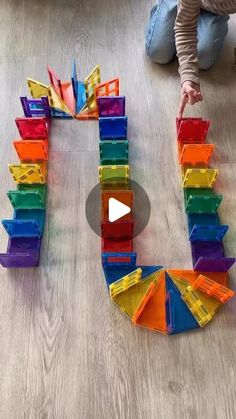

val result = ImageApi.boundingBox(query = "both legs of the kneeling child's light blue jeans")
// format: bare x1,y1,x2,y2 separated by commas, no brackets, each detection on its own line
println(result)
146,0,229,70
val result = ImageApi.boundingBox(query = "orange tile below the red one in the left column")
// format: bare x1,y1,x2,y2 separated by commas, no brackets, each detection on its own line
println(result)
13,140,48,162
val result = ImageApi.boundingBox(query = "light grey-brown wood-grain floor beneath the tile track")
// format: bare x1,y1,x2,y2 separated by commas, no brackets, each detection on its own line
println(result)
0,0,236,419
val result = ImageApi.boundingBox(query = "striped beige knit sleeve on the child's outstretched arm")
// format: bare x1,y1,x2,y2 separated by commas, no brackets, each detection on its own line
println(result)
174,0,200,84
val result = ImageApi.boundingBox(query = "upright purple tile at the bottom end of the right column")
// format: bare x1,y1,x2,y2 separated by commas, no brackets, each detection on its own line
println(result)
193,257,236,272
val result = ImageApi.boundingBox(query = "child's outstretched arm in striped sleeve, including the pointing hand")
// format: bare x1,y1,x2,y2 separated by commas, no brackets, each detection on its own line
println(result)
175,0,202,117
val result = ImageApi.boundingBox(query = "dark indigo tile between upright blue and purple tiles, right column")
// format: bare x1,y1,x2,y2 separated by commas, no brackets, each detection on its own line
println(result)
191,241,224,265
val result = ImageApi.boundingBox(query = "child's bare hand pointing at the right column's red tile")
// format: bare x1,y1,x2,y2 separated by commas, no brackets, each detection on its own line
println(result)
178,81,203,118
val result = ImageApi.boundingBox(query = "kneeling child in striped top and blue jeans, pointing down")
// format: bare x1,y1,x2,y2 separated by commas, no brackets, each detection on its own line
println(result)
146,0,236,118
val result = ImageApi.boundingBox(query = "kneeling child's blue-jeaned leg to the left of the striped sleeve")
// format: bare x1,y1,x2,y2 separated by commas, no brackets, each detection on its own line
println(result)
146,0,177,64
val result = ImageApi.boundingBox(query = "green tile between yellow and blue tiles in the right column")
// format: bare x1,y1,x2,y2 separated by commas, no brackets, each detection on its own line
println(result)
184,188,223,214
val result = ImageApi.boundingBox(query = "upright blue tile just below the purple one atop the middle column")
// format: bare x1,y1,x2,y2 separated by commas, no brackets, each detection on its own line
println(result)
98,116,128,140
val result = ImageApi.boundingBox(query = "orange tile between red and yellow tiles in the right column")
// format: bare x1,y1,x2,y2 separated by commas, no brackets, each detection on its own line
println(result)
178,142,215,166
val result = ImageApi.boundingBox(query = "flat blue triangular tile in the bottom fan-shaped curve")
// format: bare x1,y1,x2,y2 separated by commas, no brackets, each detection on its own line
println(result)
166,273,199,334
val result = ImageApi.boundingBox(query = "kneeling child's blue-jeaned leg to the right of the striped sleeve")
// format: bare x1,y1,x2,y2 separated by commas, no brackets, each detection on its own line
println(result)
198,10,229,70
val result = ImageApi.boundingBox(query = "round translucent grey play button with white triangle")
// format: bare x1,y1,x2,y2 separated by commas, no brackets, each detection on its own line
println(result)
85,179,151,240
